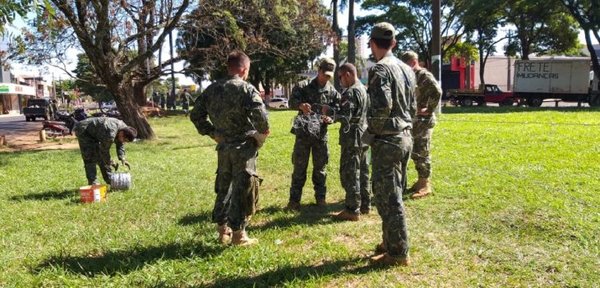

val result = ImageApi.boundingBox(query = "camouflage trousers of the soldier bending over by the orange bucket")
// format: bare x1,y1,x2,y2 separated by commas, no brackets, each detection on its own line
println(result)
77,134,112,185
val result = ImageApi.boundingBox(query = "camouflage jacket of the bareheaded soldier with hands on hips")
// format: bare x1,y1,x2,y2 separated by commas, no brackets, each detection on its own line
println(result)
190,75,269,143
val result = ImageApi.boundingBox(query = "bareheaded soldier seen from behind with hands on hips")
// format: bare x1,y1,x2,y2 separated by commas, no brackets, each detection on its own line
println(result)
190,51,269,245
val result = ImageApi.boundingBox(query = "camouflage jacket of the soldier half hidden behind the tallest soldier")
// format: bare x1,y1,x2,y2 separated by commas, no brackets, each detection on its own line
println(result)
415,68,442,121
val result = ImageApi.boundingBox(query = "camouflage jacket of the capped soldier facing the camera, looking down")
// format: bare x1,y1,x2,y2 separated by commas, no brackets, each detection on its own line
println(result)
290,77,341,139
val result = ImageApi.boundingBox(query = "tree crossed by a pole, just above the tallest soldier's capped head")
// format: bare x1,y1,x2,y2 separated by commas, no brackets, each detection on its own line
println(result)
357,0,470,63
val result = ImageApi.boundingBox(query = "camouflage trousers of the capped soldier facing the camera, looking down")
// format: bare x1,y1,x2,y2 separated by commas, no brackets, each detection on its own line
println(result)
290,136,329,203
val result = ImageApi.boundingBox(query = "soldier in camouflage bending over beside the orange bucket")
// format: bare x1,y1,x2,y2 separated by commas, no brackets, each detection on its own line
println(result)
73,117,137,185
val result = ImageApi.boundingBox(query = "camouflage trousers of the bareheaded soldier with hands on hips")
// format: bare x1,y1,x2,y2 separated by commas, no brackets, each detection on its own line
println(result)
212,141,258,231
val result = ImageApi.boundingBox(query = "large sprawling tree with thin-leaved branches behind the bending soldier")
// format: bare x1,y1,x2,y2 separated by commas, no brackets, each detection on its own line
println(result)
18,0,189,139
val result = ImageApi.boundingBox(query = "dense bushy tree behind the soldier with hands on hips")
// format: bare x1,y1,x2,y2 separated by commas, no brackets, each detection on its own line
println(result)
178,0,331,93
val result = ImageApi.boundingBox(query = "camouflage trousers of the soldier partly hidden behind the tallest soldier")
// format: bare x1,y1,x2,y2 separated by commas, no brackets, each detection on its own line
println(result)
411,117,435,178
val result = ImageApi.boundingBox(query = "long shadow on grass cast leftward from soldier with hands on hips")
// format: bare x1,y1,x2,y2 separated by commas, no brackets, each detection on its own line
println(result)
31,241,225,277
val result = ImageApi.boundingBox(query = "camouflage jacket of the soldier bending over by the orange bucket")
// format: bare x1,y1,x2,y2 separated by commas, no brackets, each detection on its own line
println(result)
74,117,127,160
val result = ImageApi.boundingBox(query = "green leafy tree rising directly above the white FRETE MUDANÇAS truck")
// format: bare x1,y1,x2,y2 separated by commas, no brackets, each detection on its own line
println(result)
505,0,579,59
